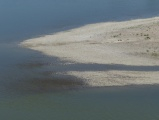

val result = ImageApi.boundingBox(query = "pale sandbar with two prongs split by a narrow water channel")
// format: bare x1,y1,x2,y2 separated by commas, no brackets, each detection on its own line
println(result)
20,17,159,86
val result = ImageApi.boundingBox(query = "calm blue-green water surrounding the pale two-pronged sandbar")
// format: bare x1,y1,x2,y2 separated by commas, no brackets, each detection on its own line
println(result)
0,0,159,120
